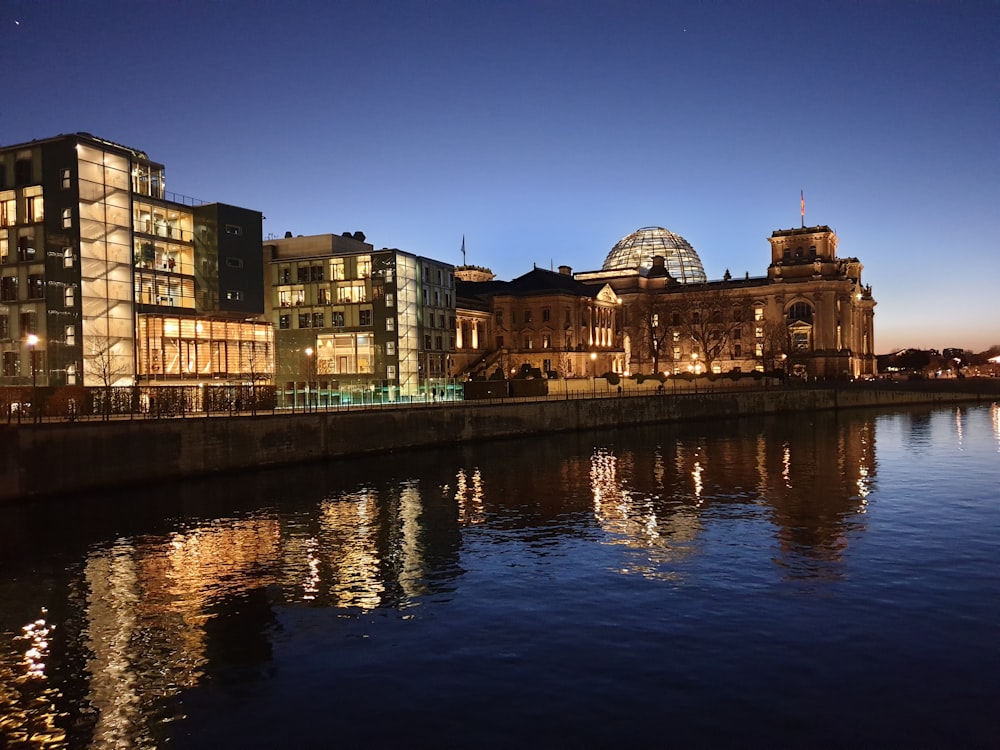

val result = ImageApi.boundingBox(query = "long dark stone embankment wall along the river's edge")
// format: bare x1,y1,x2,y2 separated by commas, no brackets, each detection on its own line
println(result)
0,389,996,502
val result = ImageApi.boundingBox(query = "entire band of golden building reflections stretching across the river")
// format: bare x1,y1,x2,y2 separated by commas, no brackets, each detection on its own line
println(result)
0,408,884,747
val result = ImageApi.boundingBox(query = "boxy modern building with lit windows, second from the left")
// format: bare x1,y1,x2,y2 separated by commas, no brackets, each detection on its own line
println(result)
264,232,455,405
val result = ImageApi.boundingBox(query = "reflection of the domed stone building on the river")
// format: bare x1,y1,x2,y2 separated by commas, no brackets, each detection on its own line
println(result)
590,414,876,580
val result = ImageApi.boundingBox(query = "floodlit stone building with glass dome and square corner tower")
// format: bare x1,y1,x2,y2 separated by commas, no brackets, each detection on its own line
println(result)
576,226,877,378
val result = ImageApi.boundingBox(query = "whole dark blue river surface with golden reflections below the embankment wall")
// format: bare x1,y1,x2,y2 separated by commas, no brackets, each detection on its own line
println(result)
0,404,1000,748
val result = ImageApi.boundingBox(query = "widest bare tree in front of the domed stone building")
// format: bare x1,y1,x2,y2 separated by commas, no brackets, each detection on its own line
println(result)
671,286,753,372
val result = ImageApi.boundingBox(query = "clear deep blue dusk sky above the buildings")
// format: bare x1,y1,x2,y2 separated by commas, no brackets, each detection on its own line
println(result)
0,0,1000,352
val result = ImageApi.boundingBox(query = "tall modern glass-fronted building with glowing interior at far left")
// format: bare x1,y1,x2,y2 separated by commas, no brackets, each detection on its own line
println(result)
0,133,273,386
